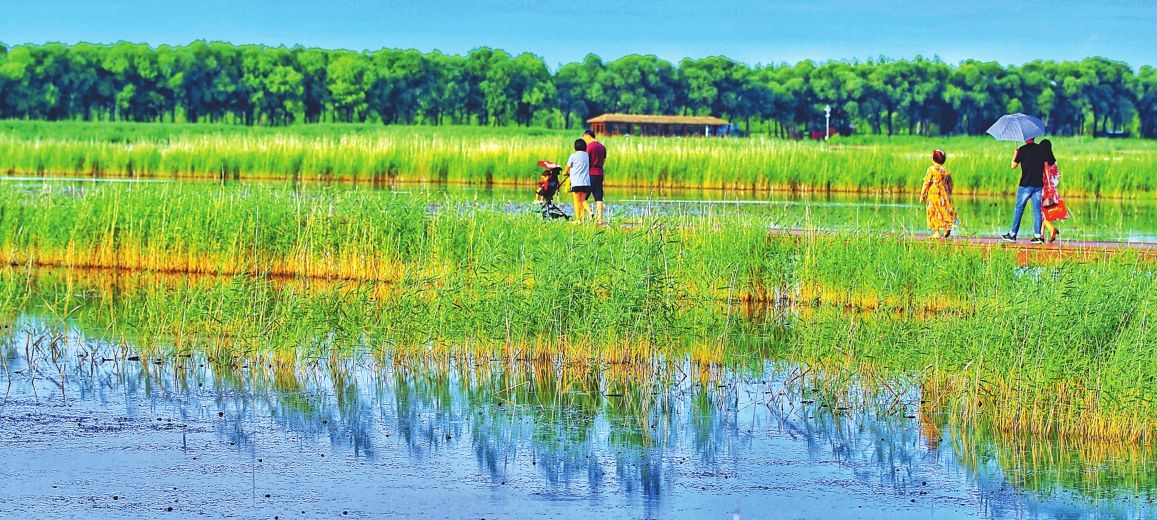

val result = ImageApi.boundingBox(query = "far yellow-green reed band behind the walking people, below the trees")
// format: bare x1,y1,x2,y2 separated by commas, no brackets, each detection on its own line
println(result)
0,122,1157,198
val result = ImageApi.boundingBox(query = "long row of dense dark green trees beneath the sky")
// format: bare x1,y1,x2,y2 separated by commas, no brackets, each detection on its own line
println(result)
0,42,1157,138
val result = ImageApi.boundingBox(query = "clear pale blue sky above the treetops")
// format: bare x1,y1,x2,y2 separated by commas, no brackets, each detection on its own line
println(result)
0,0,1157,68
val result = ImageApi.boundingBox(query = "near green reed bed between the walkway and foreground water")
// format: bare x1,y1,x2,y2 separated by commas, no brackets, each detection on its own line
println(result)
0,179,1157,442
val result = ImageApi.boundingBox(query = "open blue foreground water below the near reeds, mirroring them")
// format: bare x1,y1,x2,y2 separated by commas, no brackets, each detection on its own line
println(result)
0,326,1157,519
